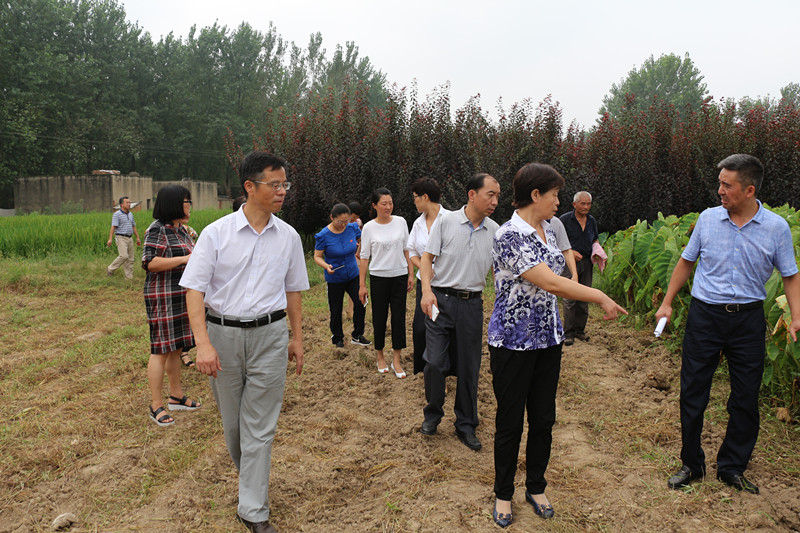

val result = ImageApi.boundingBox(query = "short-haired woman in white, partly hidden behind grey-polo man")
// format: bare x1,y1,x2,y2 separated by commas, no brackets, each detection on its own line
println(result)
406,178,455,374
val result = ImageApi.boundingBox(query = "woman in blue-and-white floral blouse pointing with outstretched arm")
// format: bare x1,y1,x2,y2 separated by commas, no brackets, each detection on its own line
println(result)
489,163,625,527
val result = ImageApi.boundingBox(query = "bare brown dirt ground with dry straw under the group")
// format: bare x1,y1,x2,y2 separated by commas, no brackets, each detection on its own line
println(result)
0,286,800,532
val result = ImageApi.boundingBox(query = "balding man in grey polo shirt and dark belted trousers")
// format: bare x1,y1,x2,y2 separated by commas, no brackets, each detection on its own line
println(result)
420,174,500,450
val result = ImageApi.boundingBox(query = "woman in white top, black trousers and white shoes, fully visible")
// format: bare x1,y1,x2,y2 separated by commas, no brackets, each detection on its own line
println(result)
358,188,414,379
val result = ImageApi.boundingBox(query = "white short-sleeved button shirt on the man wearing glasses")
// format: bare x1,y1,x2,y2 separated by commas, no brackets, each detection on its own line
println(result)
180,209,309,318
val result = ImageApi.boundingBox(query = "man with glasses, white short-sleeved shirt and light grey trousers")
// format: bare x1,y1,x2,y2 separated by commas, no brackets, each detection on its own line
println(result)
181,152,309,533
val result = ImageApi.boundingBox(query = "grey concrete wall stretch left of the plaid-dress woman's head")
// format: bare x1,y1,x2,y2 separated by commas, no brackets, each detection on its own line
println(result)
14,175,153,214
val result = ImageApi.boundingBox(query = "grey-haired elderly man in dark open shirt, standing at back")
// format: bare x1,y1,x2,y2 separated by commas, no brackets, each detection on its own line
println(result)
561,191,600,346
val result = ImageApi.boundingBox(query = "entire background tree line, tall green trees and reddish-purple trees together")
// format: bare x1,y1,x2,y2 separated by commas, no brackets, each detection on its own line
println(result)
0,0,800,232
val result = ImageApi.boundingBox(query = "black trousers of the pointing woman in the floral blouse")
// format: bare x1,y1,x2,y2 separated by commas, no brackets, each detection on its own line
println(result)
489,344,562,500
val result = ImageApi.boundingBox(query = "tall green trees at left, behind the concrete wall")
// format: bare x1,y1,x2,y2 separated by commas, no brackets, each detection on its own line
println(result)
0,0,385,207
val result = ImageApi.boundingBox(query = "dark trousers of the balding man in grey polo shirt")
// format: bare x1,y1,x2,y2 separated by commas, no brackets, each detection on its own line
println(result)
422,289,483,433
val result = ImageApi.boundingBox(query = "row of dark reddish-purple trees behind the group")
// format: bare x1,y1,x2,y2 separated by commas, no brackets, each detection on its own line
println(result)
226,78,800,233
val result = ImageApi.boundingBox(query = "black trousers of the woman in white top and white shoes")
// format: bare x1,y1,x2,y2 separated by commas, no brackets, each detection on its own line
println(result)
368,275,408,350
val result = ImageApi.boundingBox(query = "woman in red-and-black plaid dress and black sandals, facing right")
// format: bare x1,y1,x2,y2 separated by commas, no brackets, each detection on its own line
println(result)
142,185,200,426
